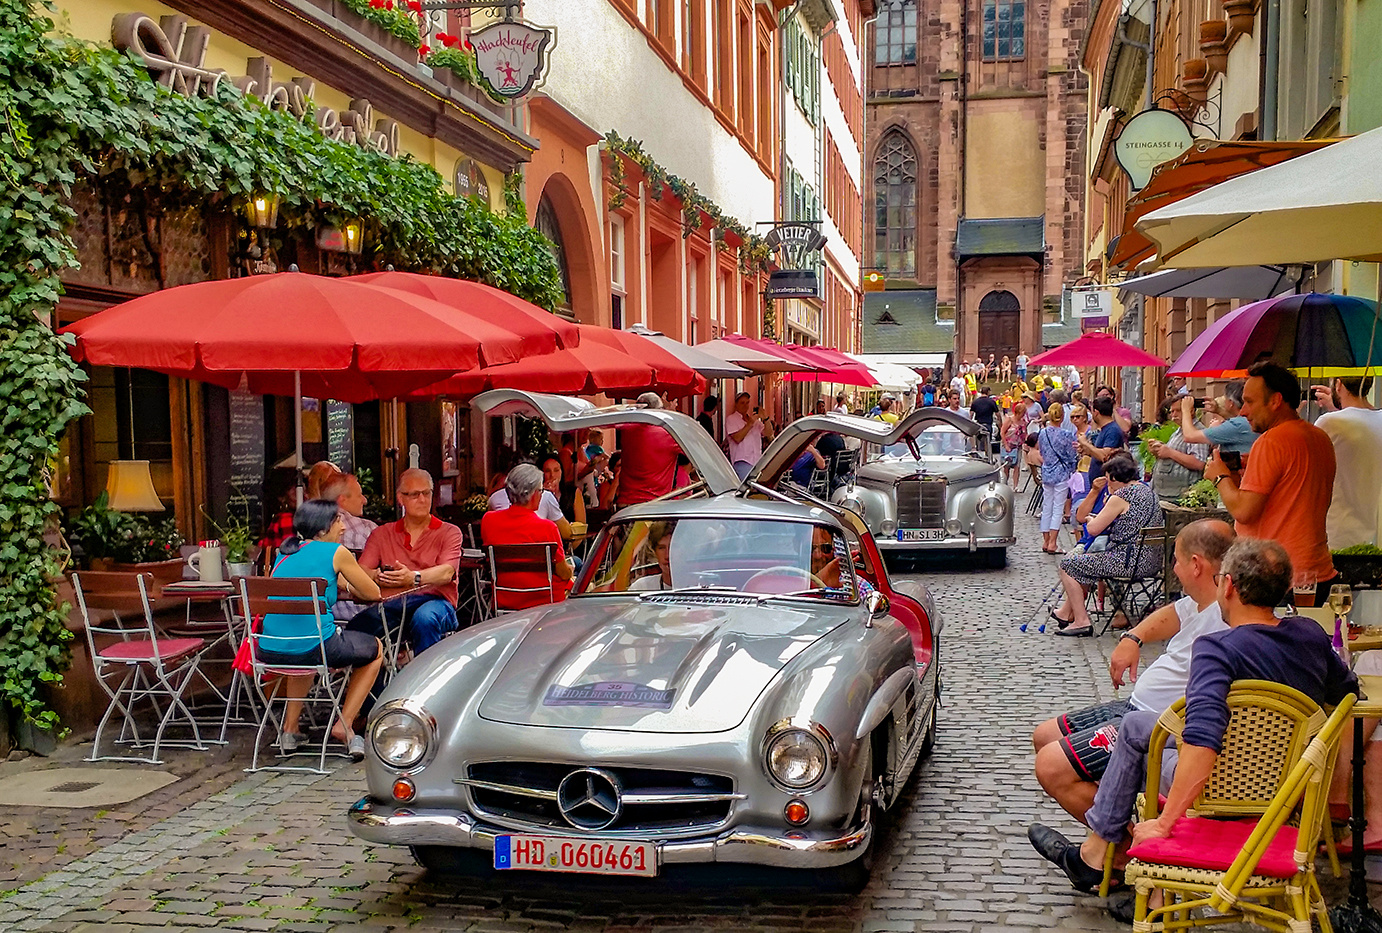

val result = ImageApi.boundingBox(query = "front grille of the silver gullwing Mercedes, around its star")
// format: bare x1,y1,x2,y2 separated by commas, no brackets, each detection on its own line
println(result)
456,762,744,835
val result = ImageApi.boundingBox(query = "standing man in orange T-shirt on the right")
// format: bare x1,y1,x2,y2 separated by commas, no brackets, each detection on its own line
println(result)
1205,362,1336,605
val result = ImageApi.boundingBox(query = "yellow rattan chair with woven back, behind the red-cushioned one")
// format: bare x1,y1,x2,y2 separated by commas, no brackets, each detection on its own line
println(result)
1099,680,1324,897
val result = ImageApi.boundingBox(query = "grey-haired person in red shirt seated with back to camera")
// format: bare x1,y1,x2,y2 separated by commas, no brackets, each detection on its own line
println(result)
480,463,575,611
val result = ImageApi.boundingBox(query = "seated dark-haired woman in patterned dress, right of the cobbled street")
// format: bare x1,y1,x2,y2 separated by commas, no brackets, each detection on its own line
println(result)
1052,453,1165,636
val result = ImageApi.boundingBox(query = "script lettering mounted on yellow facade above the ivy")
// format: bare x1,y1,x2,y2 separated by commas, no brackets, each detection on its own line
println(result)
111,12,398,156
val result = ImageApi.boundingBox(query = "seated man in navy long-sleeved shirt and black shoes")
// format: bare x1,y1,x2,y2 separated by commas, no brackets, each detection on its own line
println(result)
1027,538,1359,892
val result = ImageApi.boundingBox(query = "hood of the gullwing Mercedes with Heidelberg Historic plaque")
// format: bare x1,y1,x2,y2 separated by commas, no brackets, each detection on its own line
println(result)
480,596,854,733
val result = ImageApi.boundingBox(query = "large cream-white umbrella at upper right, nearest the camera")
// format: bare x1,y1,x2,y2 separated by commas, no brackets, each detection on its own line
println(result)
1137,129,1382,268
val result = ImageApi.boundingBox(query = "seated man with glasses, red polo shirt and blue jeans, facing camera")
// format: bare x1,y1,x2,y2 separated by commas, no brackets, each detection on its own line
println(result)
346,470,462,655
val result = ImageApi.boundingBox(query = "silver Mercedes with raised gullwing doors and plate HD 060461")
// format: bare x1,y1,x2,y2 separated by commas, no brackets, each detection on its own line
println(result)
348,390,941,889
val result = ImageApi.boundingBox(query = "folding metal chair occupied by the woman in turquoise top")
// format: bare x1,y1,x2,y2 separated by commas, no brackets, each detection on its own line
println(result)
239,576,344,774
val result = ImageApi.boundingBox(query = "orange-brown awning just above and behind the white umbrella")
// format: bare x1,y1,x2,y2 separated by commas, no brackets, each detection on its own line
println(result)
1110,140,1332,268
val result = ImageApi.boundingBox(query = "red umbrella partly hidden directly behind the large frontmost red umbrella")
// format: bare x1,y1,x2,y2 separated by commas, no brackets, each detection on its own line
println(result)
350,272,580,364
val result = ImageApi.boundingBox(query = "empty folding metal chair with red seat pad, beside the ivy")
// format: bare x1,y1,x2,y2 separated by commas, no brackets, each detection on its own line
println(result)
72,571,206,764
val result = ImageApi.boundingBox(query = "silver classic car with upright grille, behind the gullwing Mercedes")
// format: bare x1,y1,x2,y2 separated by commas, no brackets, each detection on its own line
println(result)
832,408,1016,567
